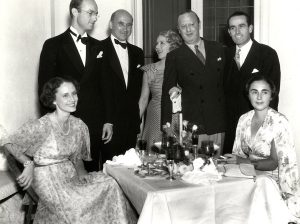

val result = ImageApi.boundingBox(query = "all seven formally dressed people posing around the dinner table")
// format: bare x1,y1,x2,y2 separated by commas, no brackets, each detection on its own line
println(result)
1,0,300,223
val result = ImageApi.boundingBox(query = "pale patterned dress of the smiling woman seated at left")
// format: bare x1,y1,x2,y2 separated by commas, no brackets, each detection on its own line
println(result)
8,115,136,224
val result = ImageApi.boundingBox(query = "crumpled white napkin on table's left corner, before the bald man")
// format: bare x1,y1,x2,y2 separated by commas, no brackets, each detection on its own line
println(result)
106,148,142,167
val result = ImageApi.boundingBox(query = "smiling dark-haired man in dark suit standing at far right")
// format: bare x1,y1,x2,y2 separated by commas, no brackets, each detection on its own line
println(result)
224,11,280,153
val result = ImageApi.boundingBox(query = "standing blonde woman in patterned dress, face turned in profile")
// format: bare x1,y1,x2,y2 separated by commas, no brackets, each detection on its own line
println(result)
139,30,182,149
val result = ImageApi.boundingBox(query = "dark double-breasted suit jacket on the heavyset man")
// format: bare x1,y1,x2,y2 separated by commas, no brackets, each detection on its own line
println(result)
161,40,225,134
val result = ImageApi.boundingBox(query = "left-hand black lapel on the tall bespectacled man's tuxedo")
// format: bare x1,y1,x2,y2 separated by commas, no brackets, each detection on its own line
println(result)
63,31,84,73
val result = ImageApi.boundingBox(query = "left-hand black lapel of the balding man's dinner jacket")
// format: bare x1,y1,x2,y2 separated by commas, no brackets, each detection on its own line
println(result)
107,37,126,89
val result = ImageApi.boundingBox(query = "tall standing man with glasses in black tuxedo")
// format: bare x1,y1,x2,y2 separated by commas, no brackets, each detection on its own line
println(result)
38,0,113,171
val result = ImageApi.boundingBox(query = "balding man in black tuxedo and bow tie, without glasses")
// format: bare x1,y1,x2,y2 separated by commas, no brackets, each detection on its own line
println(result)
102,9,144,162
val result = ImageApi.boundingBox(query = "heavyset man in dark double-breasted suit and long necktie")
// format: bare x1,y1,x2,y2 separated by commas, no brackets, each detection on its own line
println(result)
161,11,225,150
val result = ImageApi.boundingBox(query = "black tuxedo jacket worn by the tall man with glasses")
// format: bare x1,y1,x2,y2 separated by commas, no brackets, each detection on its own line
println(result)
38,29,113,131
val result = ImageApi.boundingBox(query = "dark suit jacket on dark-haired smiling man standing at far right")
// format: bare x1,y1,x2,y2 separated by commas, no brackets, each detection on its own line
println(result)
224,40,280,126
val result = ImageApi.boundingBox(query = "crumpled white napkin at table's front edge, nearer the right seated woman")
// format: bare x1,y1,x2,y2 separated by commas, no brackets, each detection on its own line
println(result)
182,158,222,185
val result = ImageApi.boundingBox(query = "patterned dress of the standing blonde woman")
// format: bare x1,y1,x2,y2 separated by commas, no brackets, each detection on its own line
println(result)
142,64,164,149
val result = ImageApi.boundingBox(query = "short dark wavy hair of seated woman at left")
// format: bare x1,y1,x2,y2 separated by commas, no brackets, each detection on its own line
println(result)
40,77,79,110
